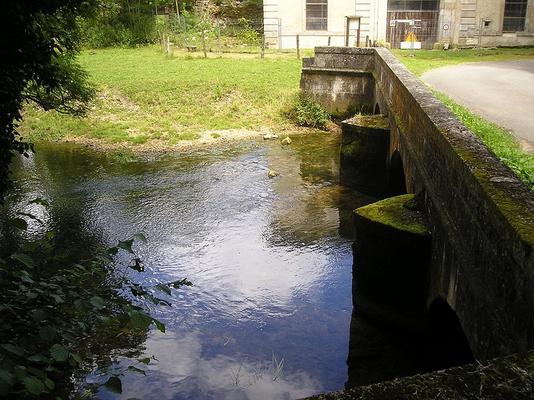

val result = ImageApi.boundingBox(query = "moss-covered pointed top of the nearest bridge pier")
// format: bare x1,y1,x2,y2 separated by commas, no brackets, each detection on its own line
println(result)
355,194,430,236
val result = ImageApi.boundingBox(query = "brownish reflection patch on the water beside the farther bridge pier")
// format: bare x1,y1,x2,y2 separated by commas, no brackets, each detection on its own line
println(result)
267,132,376,247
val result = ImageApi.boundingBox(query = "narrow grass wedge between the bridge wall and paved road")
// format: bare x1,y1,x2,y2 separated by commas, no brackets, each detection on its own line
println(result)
434,92,534,190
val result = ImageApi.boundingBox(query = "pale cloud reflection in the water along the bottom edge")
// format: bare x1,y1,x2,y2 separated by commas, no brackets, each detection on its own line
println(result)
99,332,321,400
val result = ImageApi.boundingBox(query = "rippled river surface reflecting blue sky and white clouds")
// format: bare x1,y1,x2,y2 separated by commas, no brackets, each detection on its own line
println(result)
5,134,382,399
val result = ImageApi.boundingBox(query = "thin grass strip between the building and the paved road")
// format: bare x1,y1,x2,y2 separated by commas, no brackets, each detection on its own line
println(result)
392,47,534,76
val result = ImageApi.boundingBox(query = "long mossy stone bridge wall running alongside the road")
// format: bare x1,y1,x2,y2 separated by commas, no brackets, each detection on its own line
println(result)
301,48,534,359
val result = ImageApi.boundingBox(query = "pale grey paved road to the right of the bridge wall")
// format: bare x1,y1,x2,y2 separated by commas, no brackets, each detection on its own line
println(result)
422,60,534,152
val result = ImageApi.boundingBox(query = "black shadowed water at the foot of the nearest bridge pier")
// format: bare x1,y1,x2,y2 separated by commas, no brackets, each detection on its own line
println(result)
346,305,474,388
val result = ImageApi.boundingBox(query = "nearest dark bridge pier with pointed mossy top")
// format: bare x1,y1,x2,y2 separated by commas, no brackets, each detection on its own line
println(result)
353,194,432,331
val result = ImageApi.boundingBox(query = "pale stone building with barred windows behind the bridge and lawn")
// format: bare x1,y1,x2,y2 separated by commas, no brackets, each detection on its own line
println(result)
263,0,534,49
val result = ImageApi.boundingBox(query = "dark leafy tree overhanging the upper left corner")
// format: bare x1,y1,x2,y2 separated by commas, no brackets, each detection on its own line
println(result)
0,0,97,201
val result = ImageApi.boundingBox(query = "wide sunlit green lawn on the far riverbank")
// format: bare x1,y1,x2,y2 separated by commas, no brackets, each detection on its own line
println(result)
21,47,301,144
